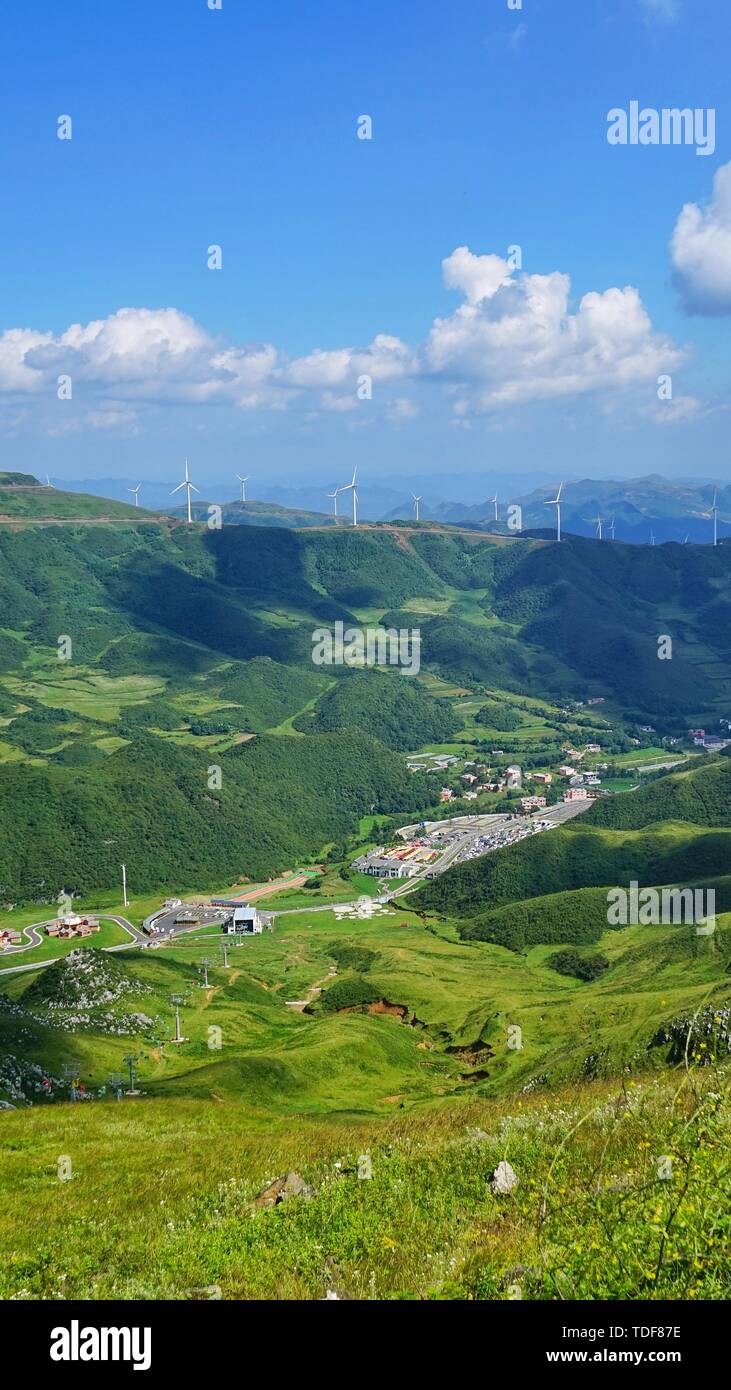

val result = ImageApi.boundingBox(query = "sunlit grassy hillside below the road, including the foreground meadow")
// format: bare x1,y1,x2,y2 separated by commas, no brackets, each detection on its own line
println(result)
0,910,731,1300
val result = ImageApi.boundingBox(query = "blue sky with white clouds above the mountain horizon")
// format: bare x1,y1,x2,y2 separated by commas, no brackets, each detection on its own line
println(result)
0,0,731,496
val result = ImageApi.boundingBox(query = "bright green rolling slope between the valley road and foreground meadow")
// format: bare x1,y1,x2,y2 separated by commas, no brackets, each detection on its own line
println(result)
0,912,731,1115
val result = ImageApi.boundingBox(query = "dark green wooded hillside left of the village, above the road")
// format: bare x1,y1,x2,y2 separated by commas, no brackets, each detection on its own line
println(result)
0,731,420,901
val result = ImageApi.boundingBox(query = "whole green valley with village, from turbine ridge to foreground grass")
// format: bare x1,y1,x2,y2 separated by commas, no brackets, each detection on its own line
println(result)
0,482,731,1298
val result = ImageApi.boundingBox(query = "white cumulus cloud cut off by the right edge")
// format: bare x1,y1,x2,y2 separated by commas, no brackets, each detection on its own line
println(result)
670,163,731,314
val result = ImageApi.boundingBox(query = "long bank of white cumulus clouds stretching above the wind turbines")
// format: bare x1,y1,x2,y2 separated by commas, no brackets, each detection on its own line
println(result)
0,247,685,430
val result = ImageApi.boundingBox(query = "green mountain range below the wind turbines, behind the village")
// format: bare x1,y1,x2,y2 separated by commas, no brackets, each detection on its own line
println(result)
0,517,731,901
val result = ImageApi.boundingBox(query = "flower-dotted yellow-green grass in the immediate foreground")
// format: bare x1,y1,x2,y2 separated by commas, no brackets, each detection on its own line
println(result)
0,1056,731,1301
